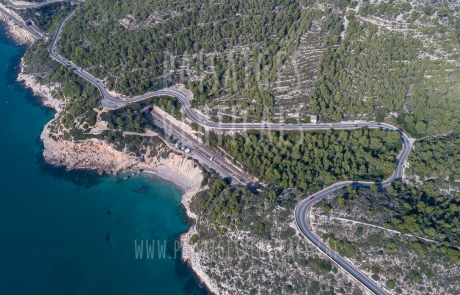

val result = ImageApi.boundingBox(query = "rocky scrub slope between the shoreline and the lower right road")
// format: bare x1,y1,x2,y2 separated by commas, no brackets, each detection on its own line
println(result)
191,175,361,294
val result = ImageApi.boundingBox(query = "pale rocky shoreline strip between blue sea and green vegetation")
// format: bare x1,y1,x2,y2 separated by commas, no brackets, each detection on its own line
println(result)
17,62,218,294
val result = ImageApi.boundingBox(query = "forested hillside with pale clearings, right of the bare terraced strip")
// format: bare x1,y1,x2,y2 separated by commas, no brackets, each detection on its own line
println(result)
307,0,460,137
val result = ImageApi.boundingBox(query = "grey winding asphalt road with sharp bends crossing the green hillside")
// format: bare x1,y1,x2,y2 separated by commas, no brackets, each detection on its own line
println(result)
6,0,411,295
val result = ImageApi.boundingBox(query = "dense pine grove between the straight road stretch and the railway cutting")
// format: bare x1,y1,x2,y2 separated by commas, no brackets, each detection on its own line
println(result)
210,129,401,190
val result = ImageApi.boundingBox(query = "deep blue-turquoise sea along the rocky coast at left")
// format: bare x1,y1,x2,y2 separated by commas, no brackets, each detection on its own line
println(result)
0,28,207,295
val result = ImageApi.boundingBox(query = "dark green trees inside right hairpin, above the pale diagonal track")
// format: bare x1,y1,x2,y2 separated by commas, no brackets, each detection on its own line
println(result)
321,181,460,263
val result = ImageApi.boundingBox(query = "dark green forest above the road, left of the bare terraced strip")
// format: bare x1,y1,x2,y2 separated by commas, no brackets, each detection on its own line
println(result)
55,0,347,119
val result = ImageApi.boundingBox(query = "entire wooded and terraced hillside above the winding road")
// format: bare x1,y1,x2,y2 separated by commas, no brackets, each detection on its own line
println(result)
45,0,460,137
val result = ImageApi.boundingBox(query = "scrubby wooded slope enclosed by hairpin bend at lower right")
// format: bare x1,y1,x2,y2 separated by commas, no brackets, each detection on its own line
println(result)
312,182,460,294
